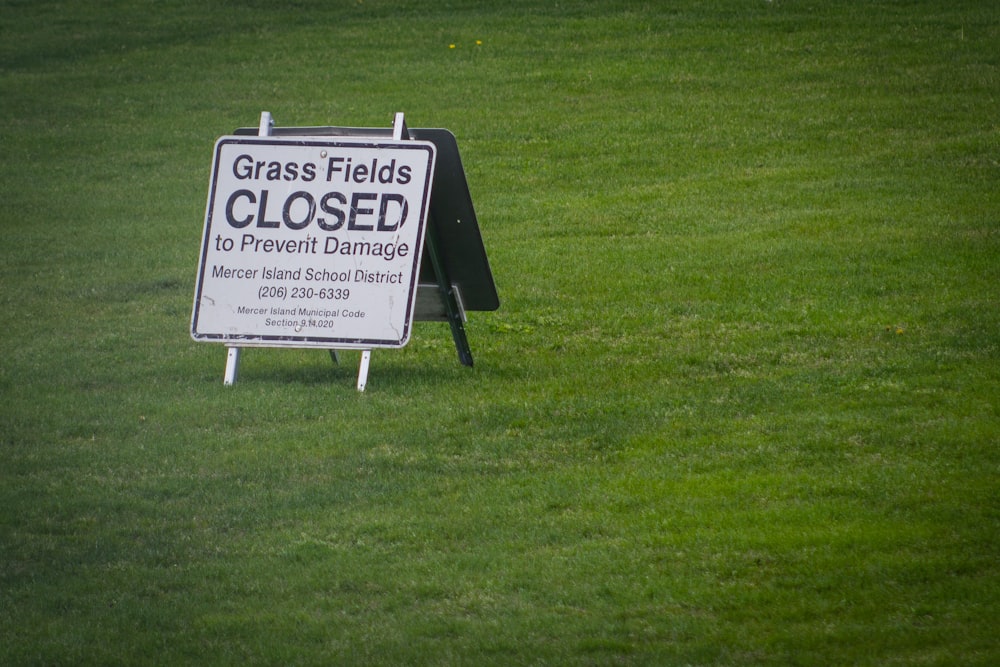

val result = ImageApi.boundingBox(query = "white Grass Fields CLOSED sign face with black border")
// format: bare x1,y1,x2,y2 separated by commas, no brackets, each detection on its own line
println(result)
191,137,435,349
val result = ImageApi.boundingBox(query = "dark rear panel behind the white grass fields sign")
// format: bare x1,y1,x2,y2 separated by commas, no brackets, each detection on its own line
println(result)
235,127,500,311
